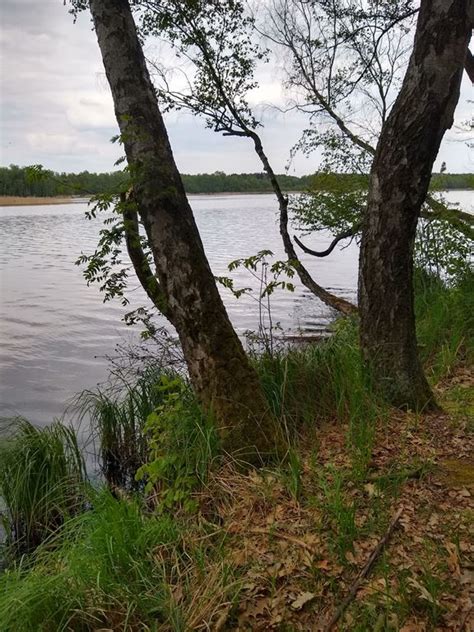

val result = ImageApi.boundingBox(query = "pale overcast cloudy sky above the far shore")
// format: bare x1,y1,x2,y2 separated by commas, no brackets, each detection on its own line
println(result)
0,0,474,175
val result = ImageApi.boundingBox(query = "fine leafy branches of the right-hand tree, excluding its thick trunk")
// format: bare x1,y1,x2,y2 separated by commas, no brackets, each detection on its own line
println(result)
262,0,474,256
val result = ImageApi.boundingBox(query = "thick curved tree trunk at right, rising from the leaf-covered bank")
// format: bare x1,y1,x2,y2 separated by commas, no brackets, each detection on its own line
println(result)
359,0,473,409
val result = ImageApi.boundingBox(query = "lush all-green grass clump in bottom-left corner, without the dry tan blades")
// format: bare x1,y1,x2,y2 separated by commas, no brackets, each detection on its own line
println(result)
0,492,179,632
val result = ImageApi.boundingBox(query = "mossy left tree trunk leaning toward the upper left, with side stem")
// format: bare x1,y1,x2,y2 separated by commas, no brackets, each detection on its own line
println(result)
90,0,279,459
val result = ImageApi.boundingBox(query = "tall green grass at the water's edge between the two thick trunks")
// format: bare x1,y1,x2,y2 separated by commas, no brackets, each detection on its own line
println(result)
255,319,385,470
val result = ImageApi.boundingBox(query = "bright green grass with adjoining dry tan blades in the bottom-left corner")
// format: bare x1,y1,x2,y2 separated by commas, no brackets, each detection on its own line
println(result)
0,490,238,632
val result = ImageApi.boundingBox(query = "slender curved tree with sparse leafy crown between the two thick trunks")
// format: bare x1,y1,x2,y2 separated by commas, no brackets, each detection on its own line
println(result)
141,0,357,314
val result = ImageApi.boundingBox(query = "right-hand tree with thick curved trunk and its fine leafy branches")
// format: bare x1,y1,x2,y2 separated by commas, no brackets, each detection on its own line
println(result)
265,0,474,408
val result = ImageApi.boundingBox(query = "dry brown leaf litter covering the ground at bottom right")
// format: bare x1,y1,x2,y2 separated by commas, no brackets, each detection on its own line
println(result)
193,368,474,632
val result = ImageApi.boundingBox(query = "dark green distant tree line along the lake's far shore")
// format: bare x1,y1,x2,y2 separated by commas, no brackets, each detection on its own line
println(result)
0,165,474,197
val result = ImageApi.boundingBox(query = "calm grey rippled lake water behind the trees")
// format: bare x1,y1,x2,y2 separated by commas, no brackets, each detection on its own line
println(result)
0,192,472,424
